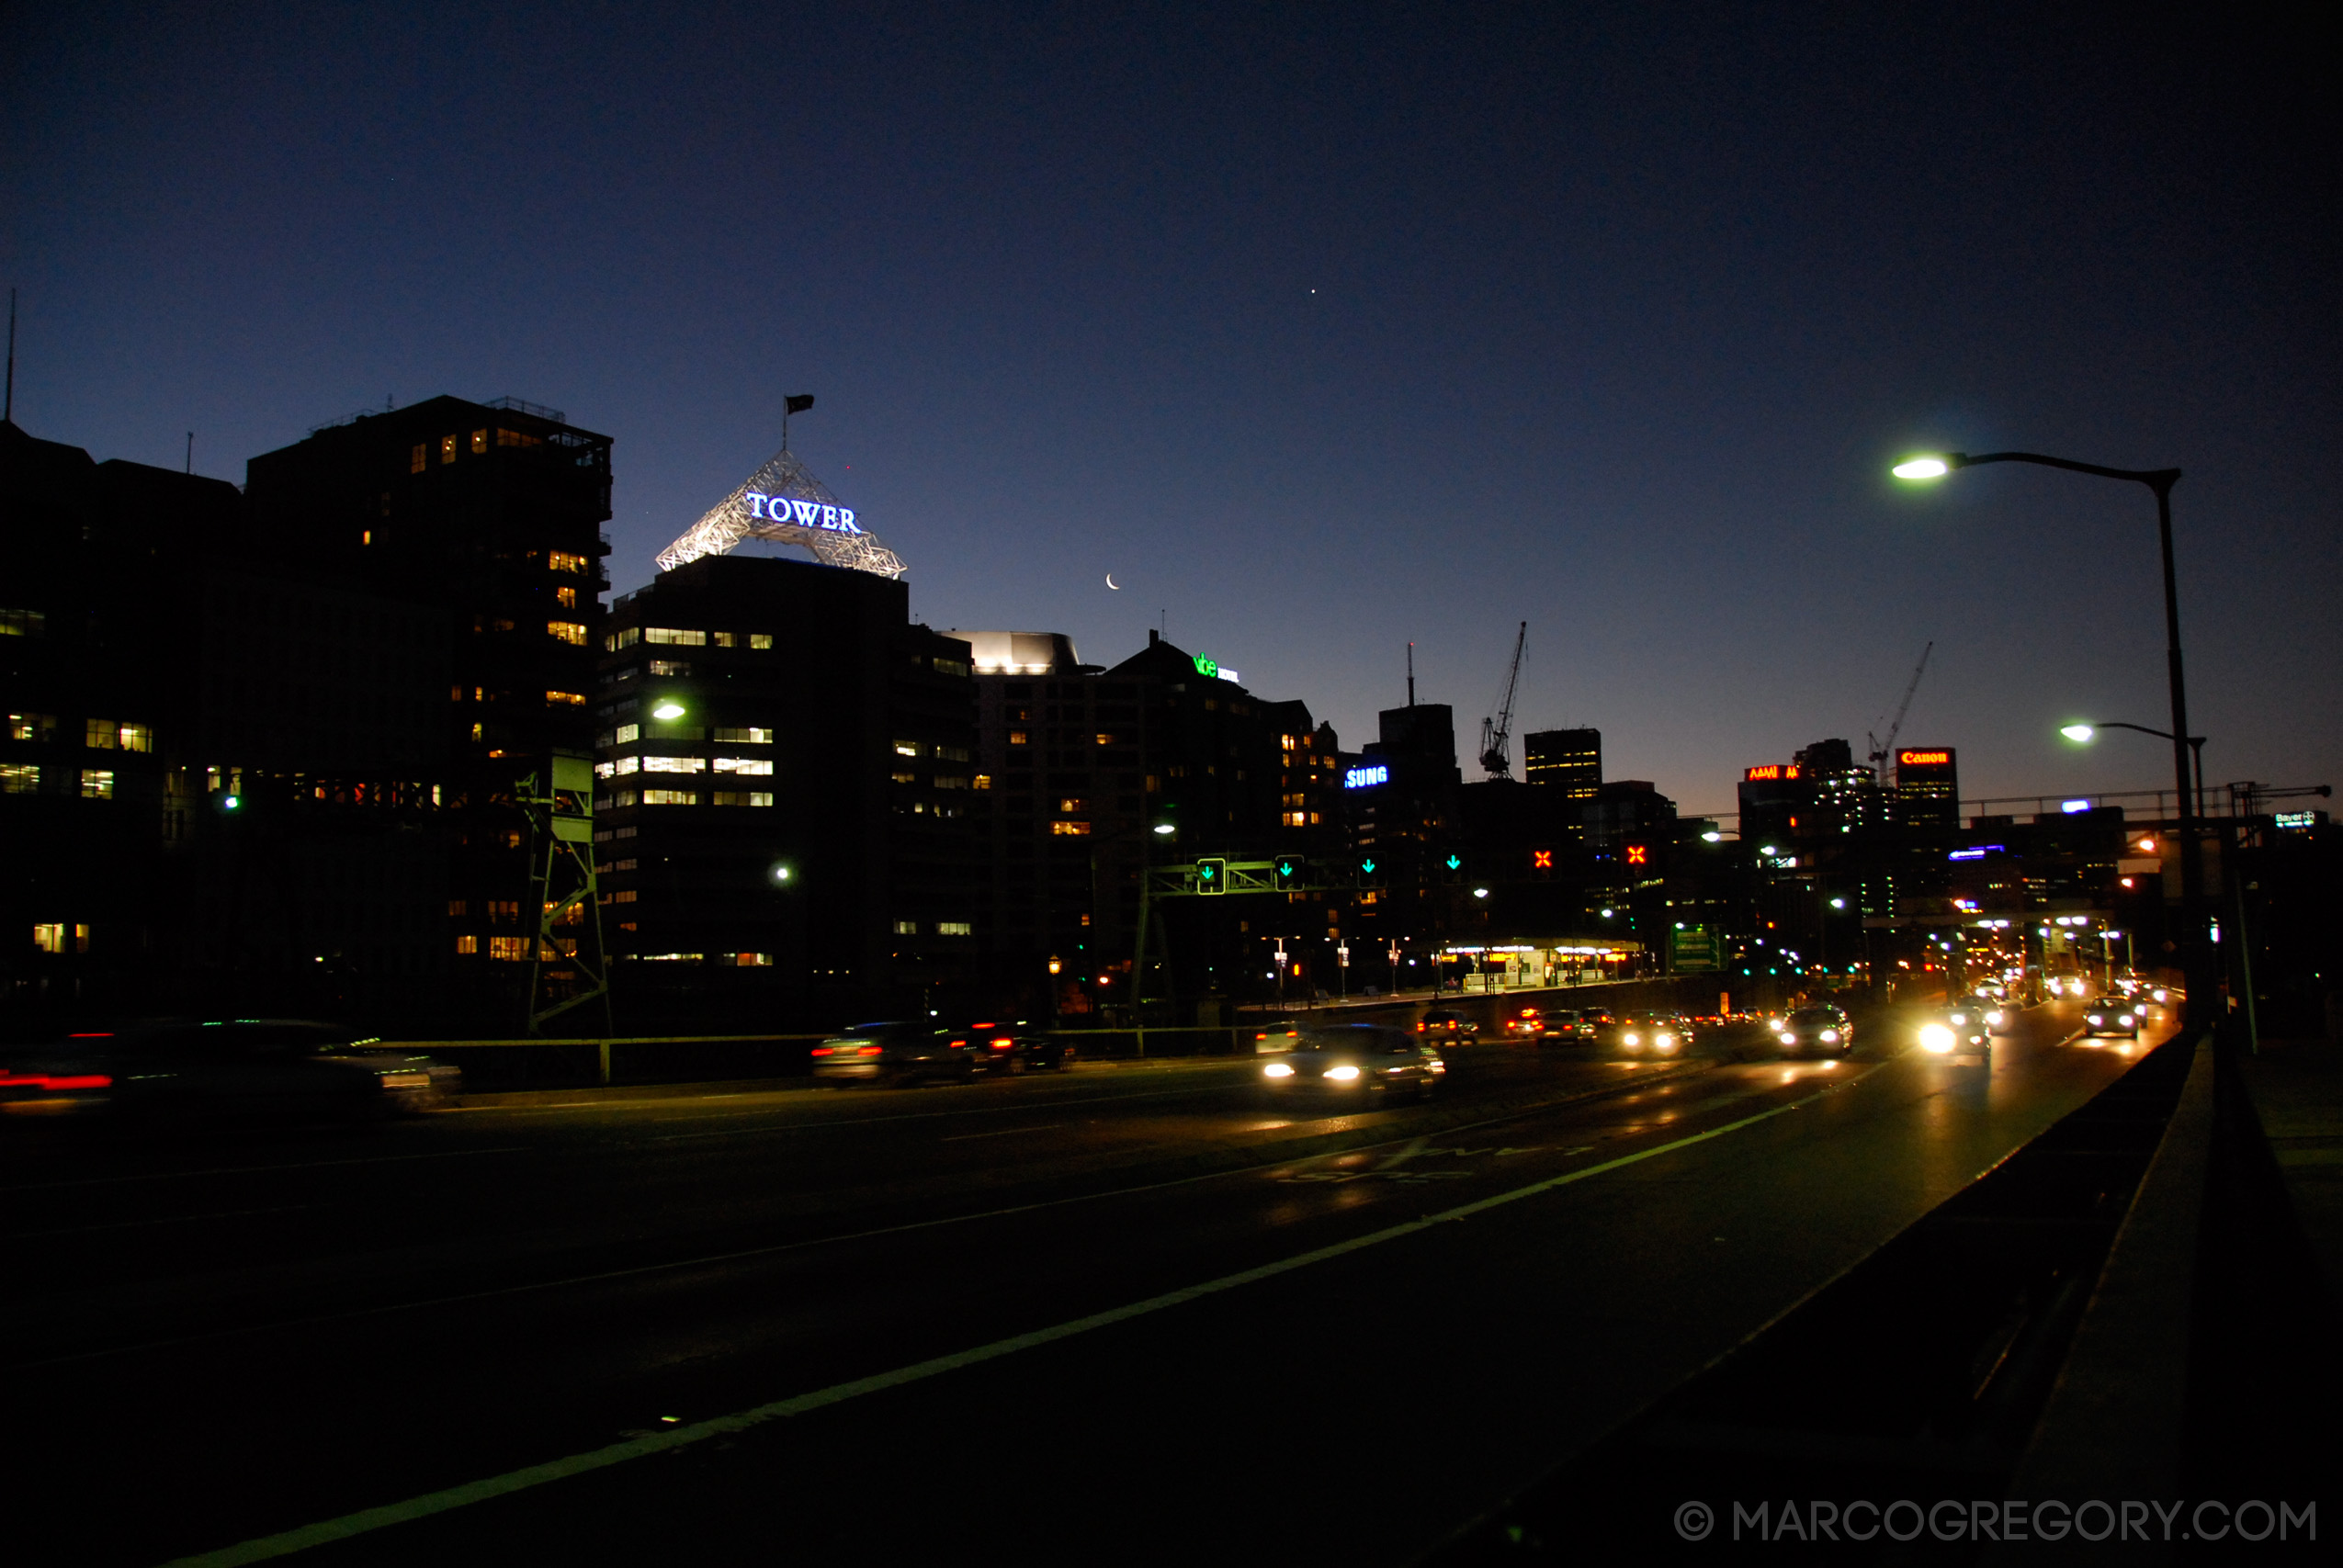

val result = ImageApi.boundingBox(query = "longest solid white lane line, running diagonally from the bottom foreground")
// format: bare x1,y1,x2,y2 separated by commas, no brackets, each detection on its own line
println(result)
164,1066,1879,1568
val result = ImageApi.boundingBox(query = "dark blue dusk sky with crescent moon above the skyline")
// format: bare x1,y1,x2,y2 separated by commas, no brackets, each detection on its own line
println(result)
0,5,2343,811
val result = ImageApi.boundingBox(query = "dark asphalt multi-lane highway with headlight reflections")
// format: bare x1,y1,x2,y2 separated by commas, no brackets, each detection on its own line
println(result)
0,1006,2163,1563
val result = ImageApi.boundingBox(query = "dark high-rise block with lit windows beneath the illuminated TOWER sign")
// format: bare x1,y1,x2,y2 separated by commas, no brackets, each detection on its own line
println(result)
593,556,981,1027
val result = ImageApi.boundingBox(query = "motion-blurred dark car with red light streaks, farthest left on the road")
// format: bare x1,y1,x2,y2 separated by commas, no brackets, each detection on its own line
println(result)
0,1017,464,1122
